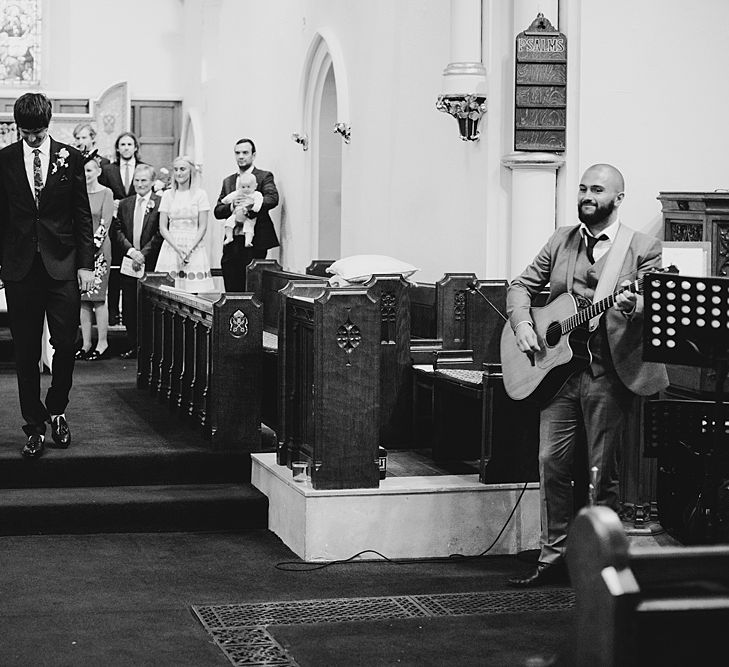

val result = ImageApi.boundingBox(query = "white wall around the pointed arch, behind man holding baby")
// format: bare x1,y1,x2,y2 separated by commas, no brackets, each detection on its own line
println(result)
178,0,488,280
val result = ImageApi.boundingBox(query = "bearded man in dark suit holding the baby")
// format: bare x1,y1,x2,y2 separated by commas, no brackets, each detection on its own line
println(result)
213,139,278,292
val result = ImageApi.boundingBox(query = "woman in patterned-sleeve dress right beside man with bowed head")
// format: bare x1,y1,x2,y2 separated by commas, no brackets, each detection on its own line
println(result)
76,155,114,361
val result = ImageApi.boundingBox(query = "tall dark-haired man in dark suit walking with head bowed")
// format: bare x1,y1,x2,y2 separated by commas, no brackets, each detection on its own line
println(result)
0,93,94,458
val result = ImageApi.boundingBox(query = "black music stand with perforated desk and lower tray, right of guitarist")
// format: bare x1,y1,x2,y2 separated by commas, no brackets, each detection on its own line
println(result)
643,273,729,543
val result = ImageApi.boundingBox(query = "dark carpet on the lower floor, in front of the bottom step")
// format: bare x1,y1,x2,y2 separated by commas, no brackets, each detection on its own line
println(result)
0,529,571,667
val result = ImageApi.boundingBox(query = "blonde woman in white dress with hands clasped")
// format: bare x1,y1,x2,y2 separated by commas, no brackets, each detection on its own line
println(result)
155,155,215,293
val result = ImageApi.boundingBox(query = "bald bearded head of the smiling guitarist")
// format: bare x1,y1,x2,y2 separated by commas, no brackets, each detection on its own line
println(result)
577,164,625,233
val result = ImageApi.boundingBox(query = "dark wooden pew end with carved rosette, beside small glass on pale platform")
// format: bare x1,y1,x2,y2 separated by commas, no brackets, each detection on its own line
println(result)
279,278,384,489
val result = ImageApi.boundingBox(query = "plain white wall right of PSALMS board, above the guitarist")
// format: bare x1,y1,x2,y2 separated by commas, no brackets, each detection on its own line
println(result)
560,0,729,239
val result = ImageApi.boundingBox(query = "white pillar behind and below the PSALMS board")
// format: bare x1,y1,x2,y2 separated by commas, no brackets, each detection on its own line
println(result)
501,0,564,279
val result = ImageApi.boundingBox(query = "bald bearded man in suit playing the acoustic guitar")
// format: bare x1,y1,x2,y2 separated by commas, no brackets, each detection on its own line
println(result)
506,164,668,587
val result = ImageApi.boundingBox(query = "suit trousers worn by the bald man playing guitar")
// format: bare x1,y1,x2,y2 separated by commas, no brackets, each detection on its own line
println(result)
539,364,636,563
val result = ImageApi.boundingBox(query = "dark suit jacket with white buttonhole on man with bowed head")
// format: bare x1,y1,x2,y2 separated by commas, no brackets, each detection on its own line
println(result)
0,139,95,280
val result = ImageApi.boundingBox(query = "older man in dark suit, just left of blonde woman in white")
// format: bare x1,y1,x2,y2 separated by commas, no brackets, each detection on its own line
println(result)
110,164,162,359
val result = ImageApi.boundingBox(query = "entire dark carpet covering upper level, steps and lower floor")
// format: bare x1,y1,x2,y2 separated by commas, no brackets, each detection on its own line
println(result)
0,355,571,667
